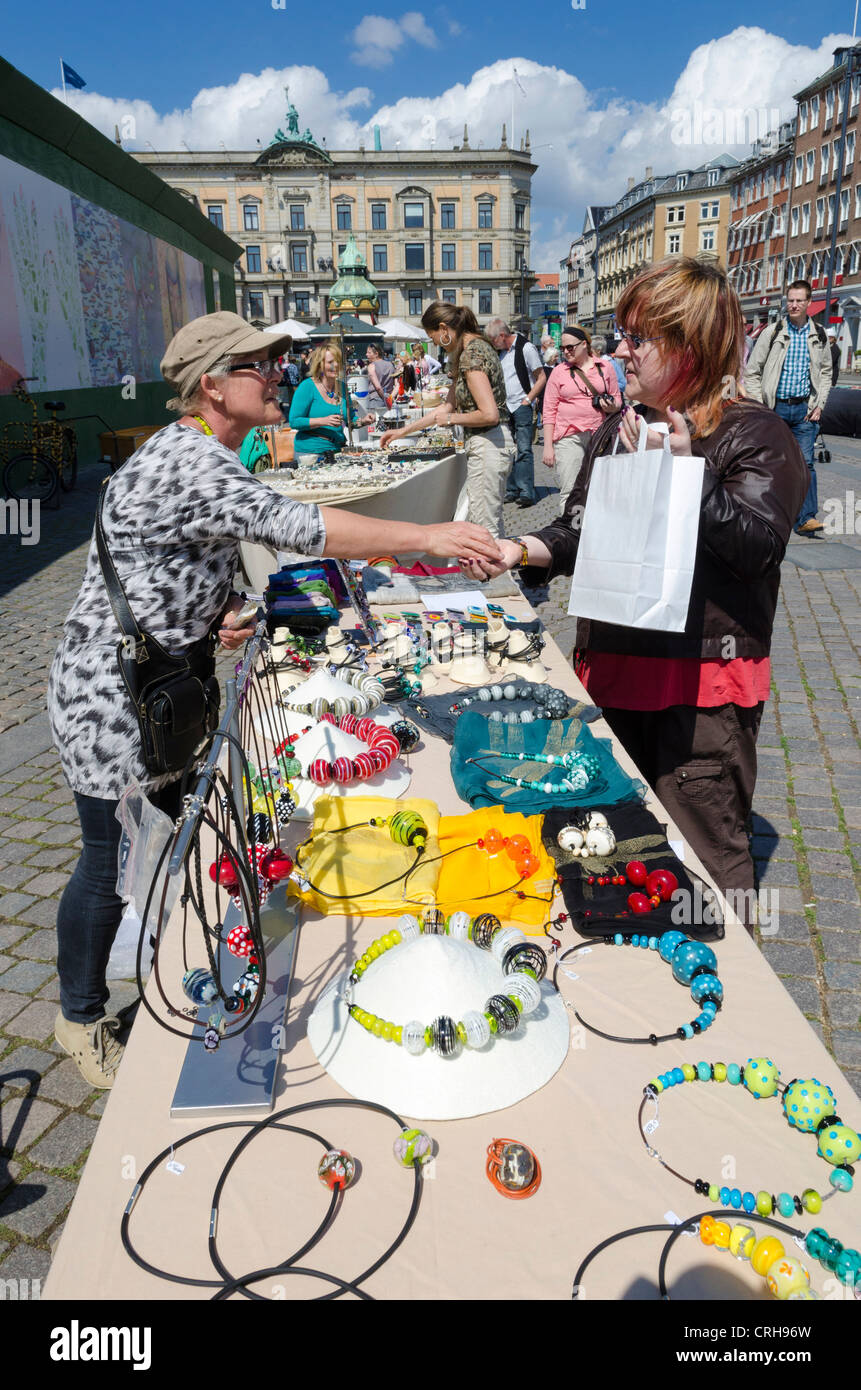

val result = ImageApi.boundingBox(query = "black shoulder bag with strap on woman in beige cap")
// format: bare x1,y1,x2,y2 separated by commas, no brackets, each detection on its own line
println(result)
96,482,220,777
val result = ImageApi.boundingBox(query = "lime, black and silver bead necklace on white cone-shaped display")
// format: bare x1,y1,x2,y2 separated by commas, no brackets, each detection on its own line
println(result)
346,908,547,1056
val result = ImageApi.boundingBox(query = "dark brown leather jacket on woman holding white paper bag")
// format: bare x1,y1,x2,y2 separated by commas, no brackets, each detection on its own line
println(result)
520,400,808,659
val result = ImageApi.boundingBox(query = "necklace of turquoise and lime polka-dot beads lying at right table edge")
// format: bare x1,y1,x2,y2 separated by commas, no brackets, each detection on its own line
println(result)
637,1056,861,1216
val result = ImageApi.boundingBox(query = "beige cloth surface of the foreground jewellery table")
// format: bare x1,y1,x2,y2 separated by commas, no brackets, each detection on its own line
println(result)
43,600,861,1314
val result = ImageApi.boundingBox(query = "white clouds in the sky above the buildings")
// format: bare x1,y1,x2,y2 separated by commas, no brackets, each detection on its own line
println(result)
55,31,848,271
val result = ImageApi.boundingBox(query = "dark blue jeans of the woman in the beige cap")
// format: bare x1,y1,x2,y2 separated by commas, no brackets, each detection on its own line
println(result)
57,781,181,1023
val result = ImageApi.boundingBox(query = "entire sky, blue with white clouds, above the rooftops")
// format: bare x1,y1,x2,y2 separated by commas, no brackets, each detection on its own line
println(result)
3,0,854,261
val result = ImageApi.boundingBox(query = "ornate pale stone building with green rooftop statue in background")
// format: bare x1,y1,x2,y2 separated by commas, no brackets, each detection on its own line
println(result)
135,99,537,322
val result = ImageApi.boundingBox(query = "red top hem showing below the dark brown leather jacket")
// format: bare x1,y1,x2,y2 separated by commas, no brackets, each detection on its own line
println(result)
576,652,771,710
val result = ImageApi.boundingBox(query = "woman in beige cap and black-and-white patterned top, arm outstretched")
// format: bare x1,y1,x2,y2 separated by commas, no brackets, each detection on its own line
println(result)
49,313,499,1087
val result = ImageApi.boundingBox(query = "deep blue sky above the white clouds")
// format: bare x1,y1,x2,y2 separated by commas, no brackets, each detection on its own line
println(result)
3,0,853,118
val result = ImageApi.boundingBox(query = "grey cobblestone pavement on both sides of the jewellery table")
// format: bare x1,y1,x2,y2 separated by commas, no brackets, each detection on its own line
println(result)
0,441,861,1297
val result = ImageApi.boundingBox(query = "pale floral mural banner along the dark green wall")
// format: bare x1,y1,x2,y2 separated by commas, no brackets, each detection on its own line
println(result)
0,156,206,391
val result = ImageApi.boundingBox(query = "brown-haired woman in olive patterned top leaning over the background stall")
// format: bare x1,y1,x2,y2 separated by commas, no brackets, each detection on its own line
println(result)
380,300,515,535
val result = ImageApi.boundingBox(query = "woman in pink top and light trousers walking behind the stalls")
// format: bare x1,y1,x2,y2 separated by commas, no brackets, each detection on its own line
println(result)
541,327,622,502
